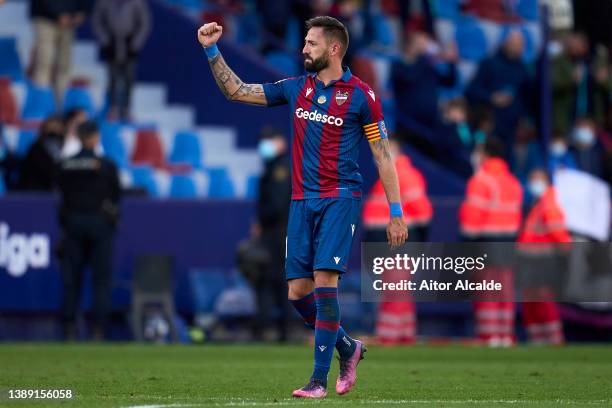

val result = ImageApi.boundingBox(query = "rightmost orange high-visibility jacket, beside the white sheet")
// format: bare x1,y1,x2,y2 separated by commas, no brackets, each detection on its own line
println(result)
518,186,571,243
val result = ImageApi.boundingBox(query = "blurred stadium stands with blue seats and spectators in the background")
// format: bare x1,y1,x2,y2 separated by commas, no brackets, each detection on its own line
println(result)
0,0,612,344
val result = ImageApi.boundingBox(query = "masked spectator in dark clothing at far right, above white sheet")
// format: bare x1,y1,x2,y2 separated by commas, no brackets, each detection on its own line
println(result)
571,118,604,178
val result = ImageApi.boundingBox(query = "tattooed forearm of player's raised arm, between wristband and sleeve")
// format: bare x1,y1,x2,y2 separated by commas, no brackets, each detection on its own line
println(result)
209,55,266,105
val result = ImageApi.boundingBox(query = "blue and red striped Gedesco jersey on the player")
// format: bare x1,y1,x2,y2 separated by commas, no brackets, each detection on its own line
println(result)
263,68,387,200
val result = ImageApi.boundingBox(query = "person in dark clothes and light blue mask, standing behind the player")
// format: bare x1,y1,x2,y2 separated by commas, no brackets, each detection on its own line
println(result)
254,127,291,341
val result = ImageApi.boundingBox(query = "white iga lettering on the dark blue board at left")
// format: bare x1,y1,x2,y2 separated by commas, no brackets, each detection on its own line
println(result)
0,222,51,278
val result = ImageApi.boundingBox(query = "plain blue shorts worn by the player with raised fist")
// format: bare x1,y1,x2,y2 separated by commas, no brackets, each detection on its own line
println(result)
285,198,361,280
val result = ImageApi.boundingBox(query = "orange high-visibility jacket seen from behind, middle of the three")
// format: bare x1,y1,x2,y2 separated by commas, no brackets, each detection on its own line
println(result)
459,158,523,238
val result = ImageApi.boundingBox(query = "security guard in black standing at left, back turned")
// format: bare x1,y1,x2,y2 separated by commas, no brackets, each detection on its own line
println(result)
58,121,120,340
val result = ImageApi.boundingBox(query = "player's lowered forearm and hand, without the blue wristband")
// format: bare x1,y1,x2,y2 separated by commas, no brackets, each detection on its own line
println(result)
370,139,408,247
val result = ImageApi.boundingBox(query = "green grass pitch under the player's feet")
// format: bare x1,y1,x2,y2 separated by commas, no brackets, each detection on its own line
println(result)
0,344,612,408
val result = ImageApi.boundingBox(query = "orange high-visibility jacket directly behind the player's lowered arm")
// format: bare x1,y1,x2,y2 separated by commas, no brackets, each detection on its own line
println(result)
363,155,433,228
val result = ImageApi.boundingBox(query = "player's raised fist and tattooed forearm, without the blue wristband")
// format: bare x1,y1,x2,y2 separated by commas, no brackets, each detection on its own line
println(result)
198,23,267,105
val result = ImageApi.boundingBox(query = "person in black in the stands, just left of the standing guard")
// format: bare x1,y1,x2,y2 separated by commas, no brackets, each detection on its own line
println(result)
19,116,65,191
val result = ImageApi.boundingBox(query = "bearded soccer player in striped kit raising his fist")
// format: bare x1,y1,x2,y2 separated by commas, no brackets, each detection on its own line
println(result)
198,16,408,398
